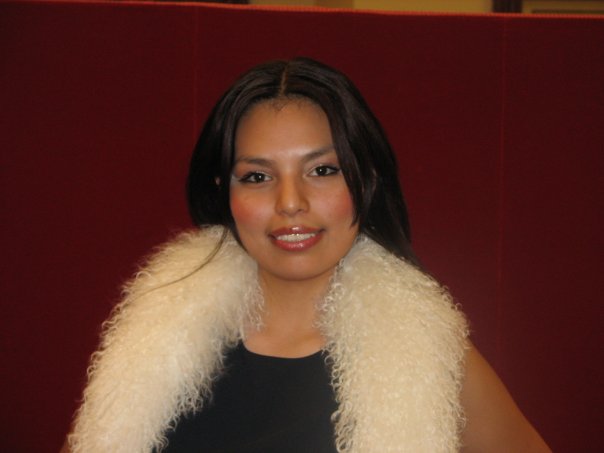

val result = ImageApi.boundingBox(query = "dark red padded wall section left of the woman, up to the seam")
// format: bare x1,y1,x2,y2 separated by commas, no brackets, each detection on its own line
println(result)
0,4,197,452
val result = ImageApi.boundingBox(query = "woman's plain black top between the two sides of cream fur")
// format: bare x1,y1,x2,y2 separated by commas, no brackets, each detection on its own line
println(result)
162,343,337,453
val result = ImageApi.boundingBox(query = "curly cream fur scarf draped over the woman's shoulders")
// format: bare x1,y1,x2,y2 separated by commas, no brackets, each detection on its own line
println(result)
69,227,467,453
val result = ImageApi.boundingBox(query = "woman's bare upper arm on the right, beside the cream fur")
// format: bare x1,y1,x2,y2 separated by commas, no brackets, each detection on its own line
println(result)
461,346,551,453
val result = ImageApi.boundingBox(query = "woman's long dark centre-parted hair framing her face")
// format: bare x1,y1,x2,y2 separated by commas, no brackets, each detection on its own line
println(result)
187,58,418,265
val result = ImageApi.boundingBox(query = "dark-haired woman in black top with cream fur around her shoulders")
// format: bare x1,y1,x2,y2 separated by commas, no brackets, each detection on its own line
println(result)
66,58,549,453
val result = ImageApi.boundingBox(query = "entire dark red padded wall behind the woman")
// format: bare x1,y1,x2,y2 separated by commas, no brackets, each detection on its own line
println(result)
0,2,604,452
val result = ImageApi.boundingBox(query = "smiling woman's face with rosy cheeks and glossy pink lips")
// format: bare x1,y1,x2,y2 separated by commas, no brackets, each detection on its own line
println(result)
230,100,358,288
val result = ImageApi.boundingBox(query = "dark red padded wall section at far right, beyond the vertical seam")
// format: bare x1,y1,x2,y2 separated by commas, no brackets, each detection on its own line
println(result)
500,18,604,452
